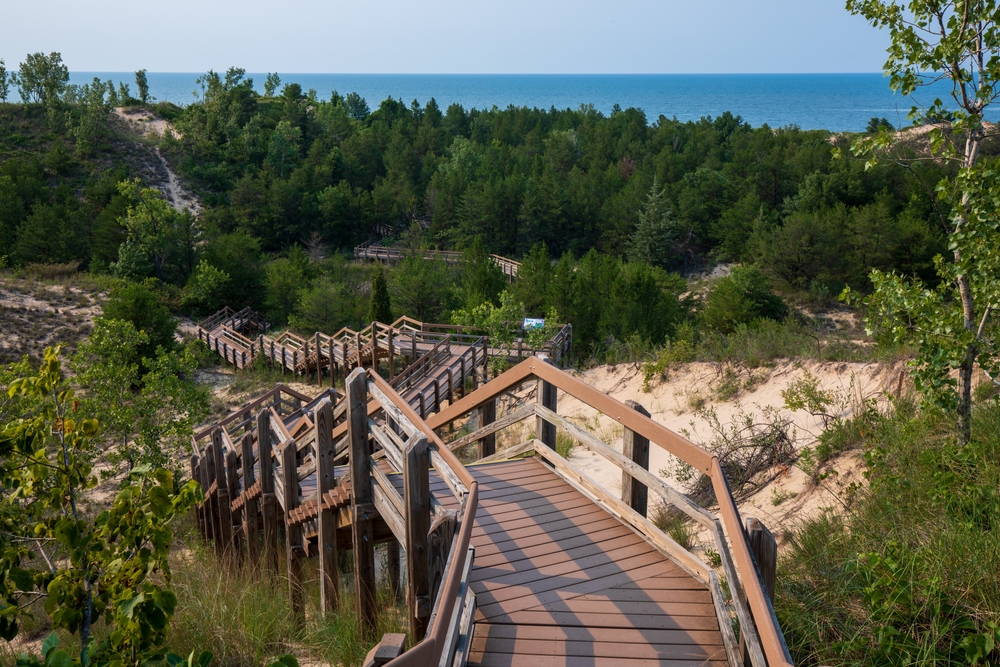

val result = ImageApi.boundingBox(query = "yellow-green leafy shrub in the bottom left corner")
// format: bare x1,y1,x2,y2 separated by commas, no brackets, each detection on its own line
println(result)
0,348,201,667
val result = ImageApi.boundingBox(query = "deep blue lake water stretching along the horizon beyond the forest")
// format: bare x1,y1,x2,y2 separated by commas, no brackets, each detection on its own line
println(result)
70,72,984,131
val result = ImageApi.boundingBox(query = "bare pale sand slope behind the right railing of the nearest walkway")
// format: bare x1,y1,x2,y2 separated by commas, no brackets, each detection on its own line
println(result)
559,362,901,533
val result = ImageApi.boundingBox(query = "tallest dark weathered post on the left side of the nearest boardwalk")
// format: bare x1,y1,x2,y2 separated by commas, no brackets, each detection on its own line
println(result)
347,368,376,629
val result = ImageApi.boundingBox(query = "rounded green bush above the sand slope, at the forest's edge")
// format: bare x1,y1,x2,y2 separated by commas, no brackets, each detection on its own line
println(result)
701,265,788,334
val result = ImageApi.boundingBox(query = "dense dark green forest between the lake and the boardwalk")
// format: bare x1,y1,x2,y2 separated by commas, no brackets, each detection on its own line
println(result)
0,54,960,355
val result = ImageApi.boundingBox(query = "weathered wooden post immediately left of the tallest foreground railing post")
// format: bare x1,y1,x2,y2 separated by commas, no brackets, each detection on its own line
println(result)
313,396,340,615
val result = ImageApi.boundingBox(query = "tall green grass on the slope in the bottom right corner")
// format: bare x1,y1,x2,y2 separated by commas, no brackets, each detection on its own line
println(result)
775,401,1000,665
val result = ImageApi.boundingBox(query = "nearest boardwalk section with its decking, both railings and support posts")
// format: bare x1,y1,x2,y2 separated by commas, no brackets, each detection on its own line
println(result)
191,346,790,667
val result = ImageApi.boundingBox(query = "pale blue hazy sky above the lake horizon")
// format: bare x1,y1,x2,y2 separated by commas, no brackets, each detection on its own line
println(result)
0,0,889,73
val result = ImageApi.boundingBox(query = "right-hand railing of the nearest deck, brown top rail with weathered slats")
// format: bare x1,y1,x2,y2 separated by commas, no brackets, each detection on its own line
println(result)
427,356,791,667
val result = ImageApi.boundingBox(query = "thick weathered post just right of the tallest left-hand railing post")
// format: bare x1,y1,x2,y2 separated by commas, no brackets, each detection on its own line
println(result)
403,433,431,641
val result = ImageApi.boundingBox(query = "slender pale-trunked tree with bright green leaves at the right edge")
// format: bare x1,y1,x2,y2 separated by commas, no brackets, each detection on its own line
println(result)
845,0,1000,442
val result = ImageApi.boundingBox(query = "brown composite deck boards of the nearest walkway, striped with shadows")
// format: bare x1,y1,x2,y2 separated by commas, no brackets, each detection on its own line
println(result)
394,458,728,667
